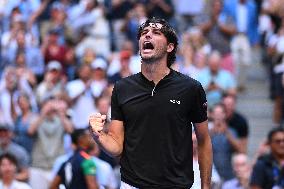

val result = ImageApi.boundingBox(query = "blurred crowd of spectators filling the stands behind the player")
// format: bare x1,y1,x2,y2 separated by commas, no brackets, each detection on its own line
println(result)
0,0,284,189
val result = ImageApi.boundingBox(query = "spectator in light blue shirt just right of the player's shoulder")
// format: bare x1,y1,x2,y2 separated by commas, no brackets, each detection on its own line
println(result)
197,51,236,107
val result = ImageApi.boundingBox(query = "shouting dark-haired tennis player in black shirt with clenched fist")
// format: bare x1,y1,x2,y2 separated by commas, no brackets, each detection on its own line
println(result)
89,18,213,189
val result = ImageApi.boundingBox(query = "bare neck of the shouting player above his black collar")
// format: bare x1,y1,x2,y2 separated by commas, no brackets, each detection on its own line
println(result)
141,63,170,84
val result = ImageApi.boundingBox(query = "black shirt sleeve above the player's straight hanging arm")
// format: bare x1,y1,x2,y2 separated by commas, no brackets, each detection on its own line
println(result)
191,82,207,123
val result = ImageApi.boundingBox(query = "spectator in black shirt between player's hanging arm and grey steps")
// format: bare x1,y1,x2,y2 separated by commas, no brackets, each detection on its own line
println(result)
222,95,249,153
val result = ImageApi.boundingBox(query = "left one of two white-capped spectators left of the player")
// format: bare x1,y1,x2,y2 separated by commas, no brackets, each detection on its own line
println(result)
36,60,65,104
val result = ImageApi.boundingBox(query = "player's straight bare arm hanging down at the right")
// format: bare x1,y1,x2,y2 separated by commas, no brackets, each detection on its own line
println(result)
194,121,213,189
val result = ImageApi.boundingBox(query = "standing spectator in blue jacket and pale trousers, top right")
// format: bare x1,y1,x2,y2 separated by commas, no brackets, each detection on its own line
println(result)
224,0,259,91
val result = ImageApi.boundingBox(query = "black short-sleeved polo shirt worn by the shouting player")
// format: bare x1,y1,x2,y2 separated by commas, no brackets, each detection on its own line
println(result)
111,70,207,189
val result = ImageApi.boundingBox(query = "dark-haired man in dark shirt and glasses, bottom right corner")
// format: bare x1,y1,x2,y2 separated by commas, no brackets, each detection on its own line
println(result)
250,127,284,189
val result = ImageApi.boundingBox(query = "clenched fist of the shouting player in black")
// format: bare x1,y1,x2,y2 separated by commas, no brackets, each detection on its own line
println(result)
89,113,106,137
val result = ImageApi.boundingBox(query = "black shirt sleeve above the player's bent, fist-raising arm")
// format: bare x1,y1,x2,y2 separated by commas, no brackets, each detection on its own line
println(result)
111,85,123,121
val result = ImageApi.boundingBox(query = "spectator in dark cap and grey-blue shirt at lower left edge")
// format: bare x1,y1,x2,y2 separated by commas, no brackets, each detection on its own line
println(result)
0,123,30,181
